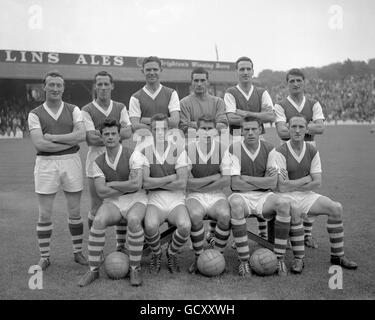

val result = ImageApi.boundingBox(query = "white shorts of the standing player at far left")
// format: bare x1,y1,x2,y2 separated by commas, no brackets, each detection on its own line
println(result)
34,152,83,194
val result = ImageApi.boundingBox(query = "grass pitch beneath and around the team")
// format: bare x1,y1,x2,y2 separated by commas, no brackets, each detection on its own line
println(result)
0,126,375,300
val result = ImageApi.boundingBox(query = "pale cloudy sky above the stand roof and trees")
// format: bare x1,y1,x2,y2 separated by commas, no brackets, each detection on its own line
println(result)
0,0,375,74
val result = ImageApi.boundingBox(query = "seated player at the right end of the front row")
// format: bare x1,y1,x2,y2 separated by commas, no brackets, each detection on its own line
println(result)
270,115,357,269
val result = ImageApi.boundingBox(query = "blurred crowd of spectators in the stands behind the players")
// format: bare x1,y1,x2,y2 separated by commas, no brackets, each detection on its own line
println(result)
0,75,375,138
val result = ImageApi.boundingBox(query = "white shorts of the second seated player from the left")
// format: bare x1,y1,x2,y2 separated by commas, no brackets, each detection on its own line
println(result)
148,190,185,215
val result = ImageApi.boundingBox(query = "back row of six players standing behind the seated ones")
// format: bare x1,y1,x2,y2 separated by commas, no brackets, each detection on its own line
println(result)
29,57,358,288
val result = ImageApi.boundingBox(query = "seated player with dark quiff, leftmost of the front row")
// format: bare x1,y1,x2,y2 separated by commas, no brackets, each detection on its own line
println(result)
78,118,147,287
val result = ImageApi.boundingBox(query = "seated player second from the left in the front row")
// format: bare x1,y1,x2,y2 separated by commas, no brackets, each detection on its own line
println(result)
142,113,191,273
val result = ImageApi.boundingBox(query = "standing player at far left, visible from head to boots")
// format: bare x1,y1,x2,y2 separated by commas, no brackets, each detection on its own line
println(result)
28,72,87,270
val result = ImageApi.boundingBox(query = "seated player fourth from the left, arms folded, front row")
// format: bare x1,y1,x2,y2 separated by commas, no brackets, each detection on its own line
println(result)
228,117,304,276
